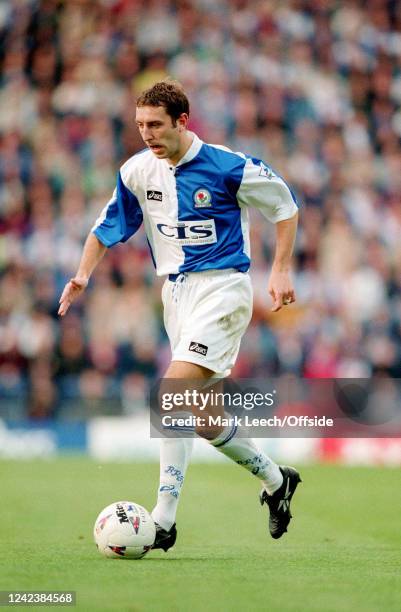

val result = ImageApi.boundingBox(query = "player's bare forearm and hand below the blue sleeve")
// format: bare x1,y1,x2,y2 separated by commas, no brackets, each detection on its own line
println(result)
58,232,107,317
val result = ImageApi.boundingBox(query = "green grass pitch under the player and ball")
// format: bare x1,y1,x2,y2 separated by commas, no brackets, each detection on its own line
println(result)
0,457,401,612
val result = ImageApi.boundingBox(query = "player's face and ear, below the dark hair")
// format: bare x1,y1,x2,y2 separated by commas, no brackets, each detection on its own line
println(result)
136,106,188,163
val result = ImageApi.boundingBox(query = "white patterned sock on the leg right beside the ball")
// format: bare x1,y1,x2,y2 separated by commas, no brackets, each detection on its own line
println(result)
151,438,194,531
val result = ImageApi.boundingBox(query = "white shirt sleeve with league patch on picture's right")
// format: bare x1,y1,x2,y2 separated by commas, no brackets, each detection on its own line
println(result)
237,158,298,223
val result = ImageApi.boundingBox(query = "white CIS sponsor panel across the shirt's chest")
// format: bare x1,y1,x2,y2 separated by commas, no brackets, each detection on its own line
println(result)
156,219,217,246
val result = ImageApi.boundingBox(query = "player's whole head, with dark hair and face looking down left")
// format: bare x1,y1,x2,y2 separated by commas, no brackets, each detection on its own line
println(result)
136,80,189,162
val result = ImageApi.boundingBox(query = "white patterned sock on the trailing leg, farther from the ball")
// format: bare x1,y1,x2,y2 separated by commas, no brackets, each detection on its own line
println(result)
210,425,283,495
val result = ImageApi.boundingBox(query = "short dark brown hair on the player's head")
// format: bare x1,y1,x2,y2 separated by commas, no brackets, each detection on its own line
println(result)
136,79,189,125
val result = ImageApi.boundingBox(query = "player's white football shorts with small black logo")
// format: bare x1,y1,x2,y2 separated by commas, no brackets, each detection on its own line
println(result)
162,270,253,377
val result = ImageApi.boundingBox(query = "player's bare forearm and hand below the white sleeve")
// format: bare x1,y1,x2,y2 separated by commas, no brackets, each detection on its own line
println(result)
268,213,298,312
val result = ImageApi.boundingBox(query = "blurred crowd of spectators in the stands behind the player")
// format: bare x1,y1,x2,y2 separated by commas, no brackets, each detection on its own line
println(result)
0,0,401,419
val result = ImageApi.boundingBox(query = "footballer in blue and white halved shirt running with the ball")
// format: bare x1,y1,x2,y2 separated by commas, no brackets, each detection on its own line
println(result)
59,80,300,551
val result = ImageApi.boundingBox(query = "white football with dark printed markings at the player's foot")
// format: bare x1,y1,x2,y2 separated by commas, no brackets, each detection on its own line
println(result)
93,501,156,559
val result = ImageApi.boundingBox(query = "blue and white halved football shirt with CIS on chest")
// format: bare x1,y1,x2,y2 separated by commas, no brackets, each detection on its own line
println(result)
92,135,297,276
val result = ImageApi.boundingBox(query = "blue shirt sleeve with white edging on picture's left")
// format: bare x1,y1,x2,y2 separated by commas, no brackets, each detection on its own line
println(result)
91,172,143,247
